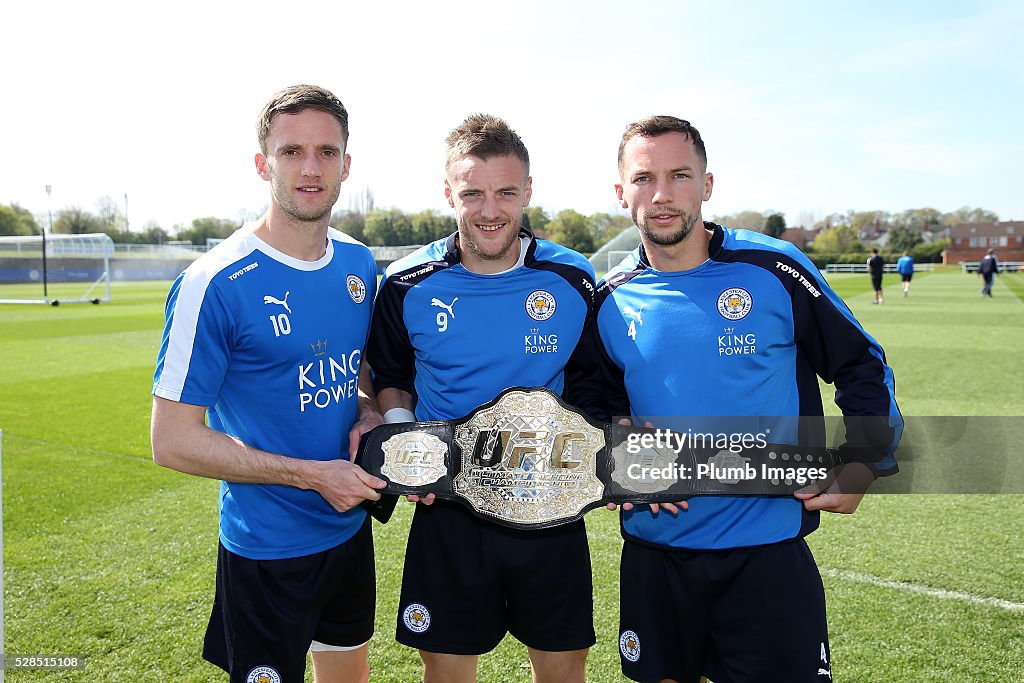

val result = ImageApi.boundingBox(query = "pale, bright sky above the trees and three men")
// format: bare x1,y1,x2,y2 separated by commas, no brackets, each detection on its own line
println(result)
0,0,1024,232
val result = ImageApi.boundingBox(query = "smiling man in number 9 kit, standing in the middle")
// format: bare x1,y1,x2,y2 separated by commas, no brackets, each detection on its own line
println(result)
367,115,595,683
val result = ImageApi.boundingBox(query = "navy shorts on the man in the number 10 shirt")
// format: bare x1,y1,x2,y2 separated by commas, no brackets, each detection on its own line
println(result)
203,517,377,683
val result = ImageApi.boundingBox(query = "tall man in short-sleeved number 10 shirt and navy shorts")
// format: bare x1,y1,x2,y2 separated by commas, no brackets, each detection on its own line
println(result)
152,85,385,683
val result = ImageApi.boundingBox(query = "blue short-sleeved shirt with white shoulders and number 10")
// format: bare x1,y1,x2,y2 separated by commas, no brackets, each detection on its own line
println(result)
153,224,377,559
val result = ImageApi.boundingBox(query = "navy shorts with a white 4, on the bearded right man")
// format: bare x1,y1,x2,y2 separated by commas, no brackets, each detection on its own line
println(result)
618,539,831,683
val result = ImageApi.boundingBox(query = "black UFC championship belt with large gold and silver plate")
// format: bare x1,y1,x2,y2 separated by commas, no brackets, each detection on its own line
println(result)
356,387,840,529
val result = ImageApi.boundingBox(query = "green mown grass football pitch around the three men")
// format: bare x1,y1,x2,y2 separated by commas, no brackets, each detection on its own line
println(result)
0,269,1024,683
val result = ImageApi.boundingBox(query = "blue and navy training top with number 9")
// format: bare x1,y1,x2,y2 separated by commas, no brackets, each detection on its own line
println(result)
367,229,594,420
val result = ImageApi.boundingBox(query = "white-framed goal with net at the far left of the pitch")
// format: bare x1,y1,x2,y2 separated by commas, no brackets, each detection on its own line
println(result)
0,232,114,306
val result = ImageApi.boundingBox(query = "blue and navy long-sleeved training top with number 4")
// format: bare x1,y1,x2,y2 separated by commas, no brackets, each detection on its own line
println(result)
568,223,902,550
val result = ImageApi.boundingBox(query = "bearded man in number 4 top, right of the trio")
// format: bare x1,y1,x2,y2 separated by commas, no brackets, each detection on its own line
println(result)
566,116,902,683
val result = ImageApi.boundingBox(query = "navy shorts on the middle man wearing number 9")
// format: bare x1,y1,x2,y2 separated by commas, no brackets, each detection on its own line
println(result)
395,501,595,654
